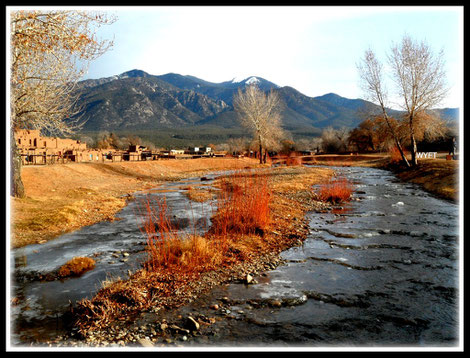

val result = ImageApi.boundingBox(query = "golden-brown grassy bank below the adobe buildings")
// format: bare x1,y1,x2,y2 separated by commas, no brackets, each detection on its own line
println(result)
10,158,266,248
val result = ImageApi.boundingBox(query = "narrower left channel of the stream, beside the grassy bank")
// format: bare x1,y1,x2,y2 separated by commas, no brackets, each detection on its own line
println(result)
10,172,220,345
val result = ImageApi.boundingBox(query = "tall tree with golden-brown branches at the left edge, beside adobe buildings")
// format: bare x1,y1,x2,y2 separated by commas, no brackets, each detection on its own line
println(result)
10,10,115,196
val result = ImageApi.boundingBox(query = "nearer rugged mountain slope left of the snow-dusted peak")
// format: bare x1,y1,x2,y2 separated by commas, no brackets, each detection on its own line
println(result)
74,70,229,131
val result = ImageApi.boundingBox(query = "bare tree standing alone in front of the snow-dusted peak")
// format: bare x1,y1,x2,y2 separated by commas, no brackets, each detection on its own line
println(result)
233,84,283,163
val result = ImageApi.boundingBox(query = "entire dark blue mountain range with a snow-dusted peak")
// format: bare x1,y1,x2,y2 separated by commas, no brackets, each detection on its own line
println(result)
73,69,458,133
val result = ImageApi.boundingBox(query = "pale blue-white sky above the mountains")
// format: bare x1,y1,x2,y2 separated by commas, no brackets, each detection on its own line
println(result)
84,6,463,107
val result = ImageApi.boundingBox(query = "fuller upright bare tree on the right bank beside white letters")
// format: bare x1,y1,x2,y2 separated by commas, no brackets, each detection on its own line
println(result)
389,36,448,165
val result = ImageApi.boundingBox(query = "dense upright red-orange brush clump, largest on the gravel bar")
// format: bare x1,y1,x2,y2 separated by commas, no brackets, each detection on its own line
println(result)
211,173,271,236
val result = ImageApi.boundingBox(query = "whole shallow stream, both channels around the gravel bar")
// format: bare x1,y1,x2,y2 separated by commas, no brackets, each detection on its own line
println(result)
10,167,461,347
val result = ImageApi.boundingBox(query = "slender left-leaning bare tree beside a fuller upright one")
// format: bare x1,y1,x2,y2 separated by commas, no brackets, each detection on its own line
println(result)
357,49,410,167
